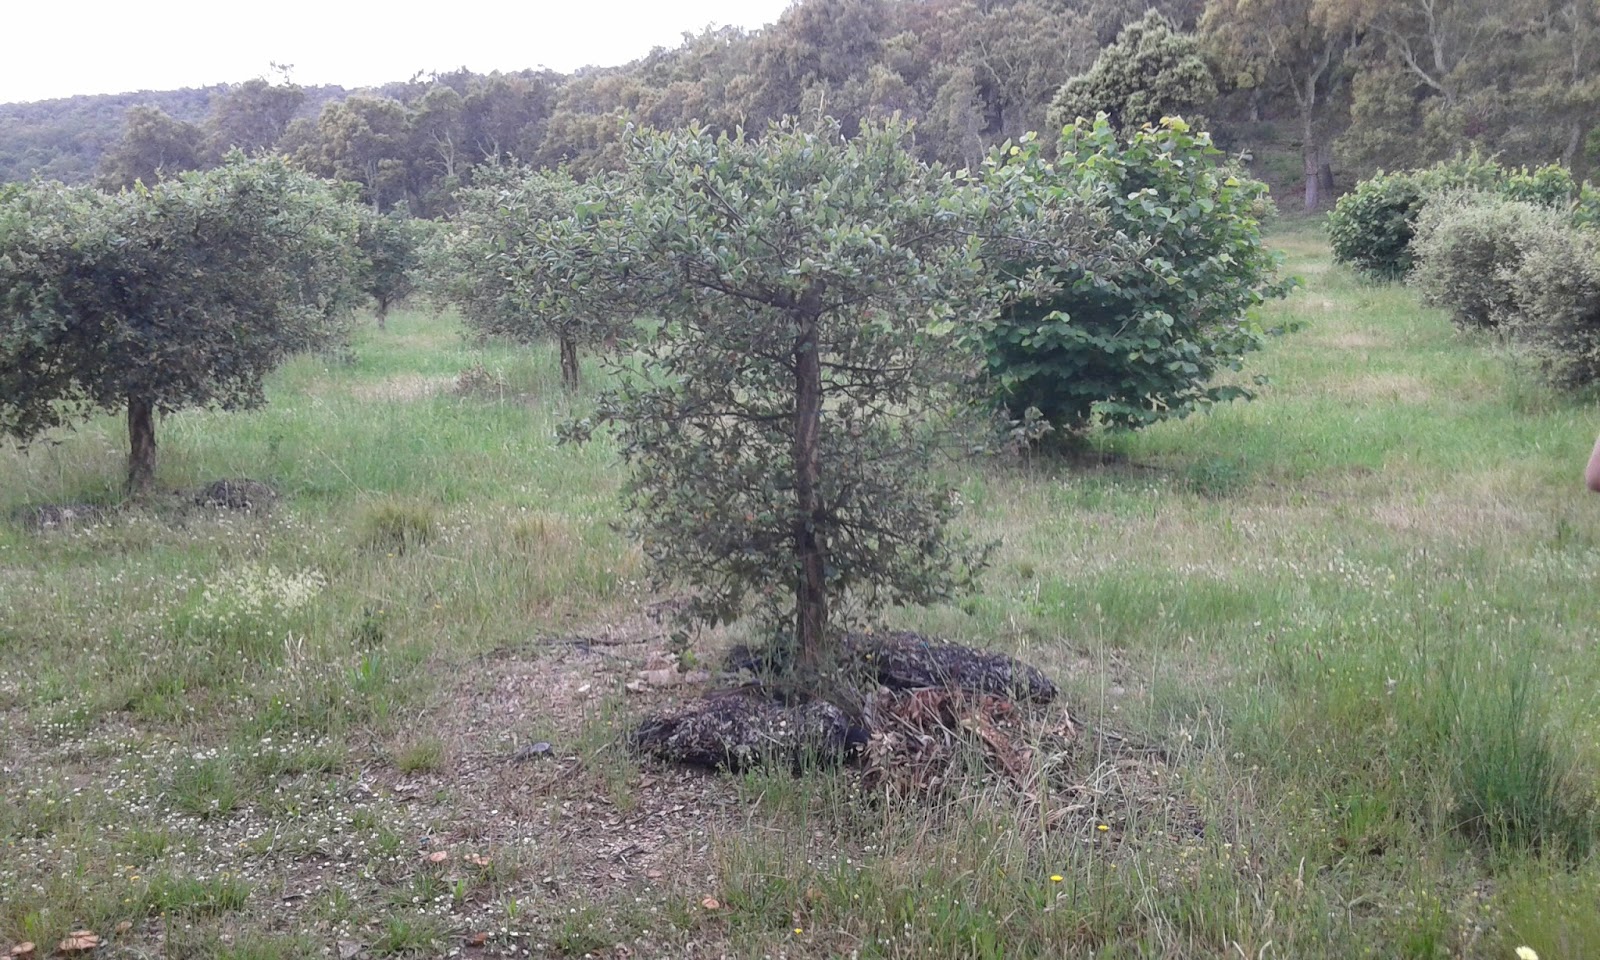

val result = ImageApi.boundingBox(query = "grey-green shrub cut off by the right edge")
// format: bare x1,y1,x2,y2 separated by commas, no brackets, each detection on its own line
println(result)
1512,222,1600,387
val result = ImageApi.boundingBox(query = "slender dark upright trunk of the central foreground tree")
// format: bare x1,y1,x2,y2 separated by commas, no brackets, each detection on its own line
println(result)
794,291,827,674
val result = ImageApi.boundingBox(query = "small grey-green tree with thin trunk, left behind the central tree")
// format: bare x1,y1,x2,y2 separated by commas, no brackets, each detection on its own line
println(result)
440,166,627,390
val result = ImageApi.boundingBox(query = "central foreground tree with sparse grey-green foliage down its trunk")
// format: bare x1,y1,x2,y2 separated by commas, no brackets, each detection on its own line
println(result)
579,122,1113,675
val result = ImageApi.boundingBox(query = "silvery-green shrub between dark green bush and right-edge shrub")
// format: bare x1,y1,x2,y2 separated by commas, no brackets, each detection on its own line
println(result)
1411,194,1566,328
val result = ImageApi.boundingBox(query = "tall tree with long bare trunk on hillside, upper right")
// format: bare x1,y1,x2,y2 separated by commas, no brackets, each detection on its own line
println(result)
1200,0,1354,210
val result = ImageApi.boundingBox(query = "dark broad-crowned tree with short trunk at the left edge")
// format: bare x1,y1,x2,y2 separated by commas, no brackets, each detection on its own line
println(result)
0,155,355,493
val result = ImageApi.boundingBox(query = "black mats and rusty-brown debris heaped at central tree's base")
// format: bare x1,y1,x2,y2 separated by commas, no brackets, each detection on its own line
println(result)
634,632,1056,782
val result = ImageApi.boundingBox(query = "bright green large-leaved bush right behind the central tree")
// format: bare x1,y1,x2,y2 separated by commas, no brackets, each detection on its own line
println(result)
982,117,1288,434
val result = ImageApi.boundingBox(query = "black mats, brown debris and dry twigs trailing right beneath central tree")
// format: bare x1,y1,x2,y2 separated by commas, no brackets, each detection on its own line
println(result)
620,634,1206,850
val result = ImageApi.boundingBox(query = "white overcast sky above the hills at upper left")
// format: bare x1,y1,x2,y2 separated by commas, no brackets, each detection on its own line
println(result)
0,0,789,102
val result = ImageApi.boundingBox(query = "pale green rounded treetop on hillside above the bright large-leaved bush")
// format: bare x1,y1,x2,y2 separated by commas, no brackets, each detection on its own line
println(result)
1050,10,1216,131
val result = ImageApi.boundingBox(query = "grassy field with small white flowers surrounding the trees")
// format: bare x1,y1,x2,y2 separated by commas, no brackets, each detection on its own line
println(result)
0,230,1600,960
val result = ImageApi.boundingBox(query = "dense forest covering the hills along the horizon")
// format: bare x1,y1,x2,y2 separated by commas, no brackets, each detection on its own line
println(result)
0,0,1600,216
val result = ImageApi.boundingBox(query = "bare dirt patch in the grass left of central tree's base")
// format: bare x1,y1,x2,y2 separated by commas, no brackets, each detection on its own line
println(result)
418,613,738,901
